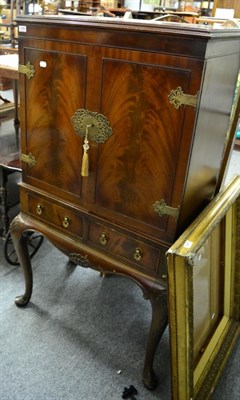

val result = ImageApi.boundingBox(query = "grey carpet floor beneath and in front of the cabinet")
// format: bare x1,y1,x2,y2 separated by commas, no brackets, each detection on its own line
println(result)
0,240,240,400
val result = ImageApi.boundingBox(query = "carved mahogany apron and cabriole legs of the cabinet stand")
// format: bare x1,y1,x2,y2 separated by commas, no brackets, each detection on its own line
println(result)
10,213,168,390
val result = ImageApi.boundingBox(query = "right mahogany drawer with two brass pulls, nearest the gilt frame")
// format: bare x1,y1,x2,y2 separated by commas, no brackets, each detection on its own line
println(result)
88,222,166,276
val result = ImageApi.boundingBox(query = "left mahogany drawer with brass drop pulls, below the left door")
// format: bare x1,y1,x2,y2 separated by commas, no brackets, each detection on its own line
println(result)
28,195,83,236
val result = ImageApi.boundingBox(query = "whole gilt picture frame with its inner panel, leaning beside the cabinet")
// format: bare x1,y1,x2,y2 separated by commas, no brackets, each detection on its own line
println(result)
167,177,240,400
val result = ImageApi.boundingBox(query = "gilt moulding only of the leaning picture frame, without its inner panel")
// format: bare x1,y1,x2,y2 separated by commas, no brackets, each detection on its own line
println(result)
167,177,240,400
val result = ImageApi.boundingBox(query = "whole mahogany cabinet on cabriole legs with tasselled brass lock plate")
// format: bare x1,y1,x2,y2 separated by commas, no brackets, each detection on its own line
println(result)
11,16,240,389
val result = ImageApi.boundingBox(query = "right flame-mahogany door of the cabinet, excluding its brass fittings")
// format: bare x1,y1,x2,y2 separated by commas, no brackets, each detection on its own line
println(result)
94,50,202,240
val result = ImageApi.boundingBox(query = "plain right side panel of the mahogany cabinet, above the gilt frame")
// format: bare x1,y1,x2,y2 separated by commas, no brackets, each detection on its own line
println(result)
179,54,240,233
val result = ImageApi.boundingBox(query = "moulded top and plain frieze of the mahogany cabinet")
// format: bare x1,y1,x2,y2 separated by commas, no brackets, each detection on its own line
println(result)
16,15,240,59
